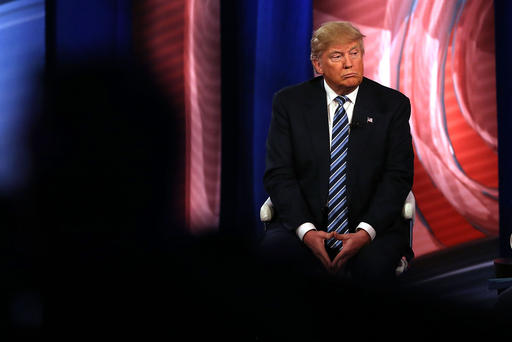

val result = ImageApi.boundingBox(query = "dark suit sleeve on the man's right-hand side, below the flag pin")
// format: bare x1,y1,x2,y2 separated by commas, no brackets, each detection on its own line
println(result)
362,98,414,236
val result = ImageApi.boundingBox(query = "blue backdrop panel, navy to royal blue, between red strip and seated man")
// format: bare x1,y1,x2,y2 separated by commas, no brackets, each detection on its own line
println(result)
217,0,312,235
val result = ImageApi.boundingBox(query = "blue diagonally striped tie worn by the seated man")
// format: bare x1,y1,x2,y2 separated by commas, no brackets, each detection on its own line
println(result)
327,96,349,250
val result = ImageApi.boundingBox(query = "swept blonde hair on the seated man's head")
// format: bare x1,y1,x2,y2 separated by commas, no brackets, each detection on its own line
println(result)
310,21,366,60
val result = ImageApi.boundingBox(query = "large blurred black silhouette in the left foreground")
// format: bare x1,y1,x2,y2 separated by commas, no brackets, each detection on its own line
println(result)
6,61,258,334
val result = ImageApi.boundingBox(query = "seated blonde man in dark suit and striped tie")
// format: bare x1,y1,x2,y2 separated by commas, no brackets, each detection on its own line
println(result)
263,22,413,289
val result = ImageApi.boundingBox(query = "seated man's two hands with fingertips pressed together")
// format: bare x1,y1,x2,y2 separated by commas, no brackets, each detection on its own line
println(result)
303,230,371,274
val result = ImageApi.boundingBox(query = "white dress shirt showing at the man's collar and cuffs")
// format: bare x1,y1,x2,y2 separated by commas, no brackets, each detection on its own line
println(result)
296,80,377,241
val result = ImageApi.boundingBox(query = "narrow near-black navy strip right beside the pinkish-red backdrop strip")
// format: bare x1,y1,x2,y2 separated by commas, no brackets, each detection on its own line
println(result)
220,0,261,235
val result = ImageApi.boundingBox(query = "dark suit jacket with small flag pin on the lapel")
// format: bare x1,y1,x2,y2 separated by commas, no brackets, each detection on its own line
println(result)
264,77,414,236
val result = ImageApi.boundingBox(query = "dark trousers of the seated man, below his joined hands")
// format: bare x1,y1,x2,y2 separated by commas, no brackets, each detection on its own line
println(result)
259,223,409,300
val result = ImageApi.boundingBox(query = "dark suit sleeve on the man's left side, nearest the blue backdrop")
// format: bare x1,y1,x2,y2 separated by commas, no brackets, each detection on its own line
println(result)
263,93,312,230
